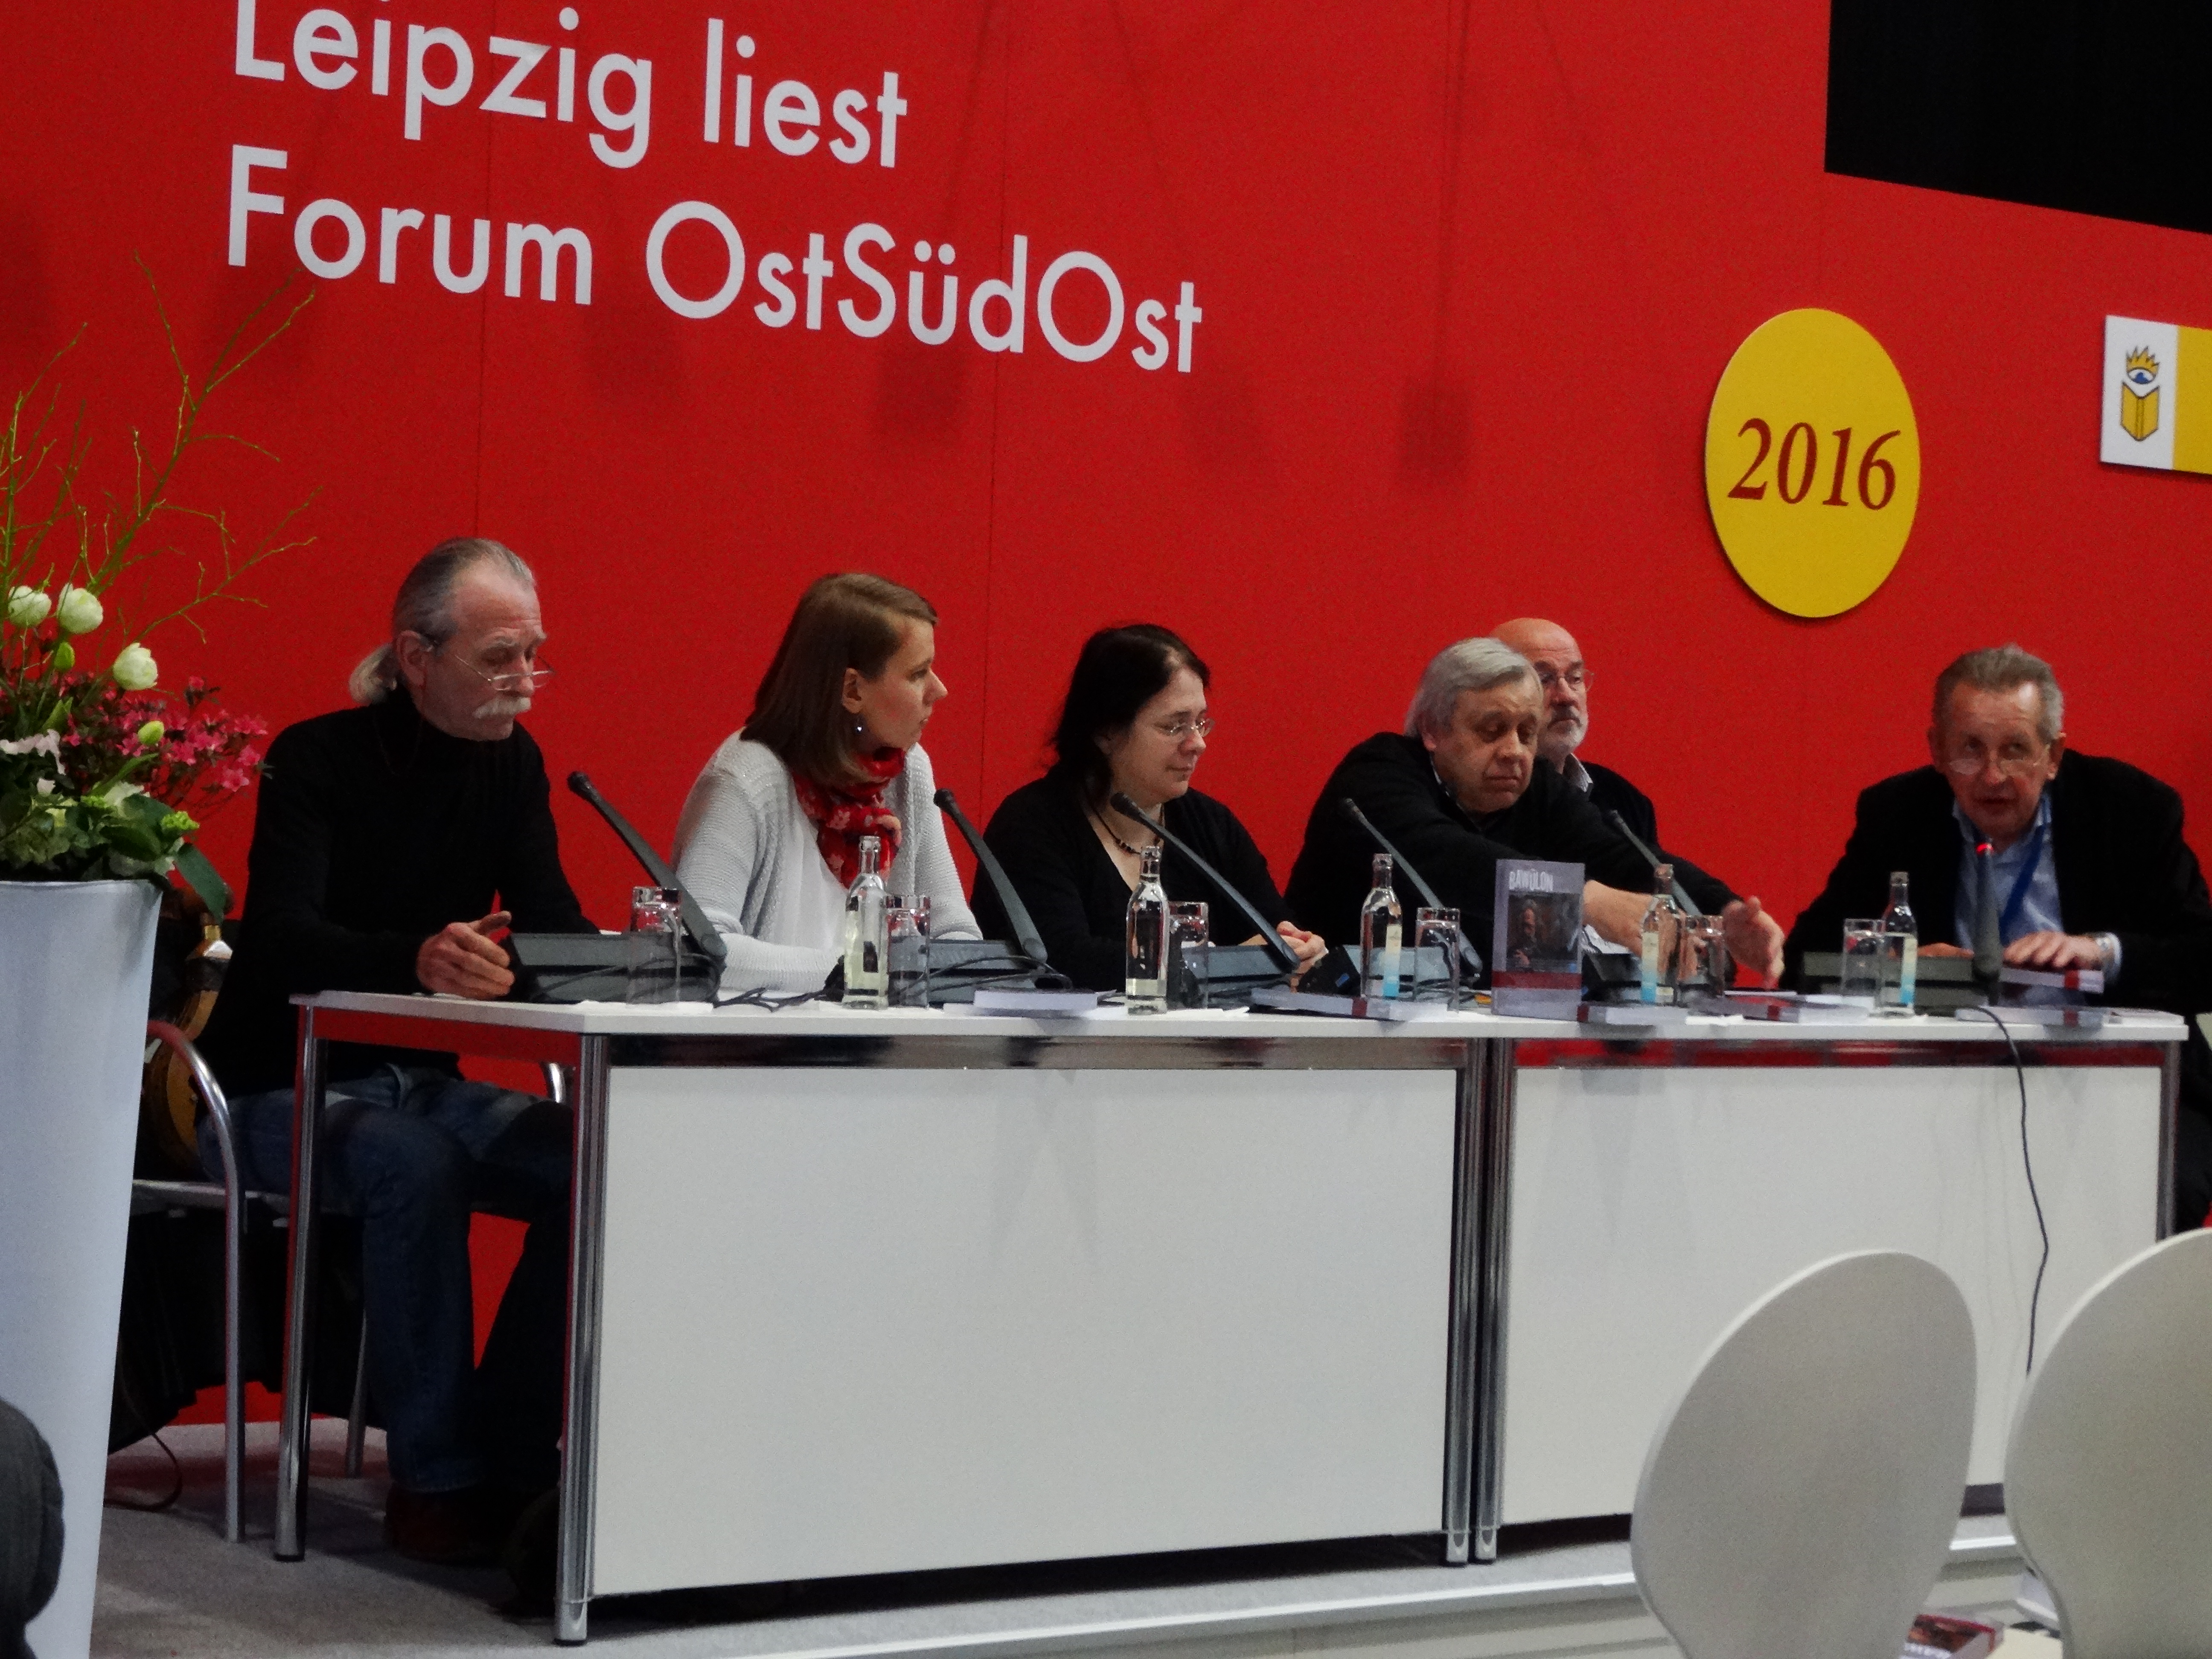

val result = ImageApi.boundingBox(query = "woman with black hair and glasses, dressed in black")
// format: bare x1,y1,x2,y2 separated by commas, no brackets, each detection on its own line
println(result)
975,624,1323,991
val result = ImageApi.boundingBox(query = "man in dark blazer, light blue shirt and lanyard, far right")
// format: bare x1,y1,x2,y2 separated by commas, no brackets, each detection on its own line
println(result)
1785,646,2212,1225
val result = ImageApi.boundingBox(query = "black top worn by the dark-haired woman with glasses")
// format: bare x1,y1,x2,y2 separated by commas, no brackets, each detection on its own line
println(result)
973,772,1289,991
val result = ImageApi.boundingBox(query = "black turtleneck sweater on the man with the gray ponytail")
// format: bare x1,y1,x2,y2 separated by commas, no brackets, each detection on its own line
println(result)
201,690,593,1095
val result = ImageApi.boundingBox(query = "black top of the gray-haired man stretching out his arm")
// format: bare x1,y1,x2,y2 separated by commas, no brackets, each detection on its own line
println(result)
1287,732,1734,955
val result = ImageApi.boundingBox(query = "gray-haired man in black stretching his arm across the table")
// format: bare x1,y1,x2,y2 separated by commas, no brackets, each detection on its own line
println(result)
1283,639,1783,984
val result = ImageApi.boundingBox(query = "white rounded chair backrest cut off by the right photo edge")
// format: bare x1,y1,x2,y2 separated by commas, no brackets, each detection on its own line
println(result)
2004,1232,2212,1659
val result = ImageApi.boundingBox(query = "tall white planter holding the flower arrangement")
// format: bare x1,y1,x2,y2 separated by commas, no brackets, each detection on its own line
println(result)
0,880,161,1659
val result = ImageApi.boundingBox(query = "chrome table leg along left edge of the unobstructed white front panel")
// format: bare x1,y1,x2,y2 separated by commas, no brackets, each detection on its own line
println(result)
553,1037,608,1646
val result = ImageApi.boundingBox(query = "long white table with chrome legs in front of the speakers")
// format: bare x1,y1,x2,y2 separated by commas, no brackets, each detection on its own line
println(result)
276,993,2181,1642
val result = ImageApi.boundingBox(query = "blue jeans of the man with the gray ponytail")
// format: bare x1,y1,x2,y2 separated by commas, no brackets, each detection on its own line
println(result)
199,1066,573,1493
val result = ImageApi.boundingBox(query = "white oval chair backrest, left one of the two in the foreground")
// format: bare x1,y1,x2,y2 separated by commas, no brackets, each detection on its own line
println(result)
1630,1250,1973,1659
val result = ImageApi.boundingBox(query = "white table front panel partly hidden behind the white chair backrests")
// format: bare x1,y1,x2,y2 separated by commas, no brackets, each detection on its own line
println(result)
1502,1066,2159,1522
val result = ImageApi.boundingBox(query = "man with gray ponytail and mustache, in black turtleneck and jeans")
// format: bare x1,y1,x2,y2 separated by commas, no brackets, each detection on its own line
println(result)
201,538,593,1562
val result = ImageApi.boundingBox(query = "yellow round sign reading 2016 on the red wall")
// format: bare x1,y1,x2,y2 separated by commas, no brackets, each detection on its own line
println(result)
1706,308,1920,617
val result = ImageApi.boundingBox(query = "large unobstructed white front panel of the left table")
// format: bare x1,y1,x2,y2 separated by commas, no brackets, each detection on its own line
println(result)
593,1066,1455,1595
